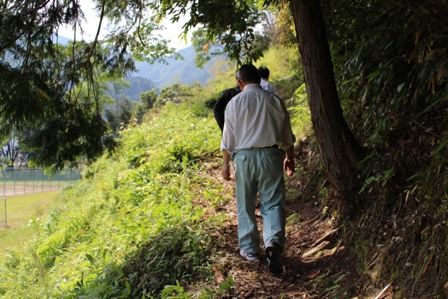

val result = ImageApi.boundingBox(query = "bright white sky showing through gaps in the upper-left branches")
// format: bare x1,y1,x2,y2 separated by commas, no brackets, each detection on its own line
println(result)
59,0,191,50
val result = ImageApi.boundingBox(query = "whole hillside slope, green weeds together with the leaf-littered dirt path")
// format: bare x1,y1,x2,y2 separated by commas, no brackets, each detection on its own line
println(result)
0,103,396,298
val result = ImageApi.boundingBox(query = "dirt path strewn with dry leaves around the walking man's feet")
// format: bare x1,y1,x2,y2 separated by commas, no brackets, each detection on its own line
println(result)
206,161,392,299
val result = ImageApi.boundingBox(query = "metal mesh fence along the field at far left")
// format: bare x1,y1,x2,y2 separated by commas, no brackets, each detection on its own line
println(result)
0,168,81,196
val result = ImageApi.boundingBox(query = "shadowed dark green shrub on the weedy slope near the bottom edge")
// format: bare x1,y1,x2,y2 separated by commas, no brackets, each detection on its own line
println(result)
117,223,210,298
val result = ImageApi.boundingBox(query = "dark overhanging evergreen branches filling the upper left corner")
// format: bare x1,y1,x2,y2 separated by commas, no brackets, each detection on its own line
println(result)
0,0,174,169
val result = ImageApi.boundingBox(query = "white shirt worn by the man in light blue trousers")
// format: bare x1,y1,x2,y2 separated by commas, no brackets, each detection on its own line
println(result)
221,83,295,155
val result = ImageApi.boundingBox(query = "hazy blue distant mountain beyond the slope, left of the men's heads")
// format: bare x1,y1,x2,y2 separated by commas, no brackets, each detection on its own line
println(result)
131,46,215,89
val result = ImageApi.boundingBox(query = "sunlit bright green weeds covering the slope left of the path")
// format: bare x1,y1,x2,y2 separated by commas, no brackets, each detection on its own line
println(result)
0,103,220,298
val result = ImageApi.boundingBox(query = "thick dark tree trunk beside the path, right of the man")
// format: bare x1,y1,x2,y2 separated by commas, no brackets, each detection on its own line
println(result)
291,0,363,196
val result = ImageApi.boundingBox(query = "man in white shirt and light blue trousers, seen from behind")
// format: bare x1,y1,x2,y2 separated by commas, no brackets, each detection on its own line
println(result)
221,65,295,273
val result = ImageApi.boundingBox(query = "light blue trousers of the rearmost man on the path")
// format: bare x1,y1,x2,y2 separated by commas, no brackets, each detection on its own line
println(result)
233,148,286,254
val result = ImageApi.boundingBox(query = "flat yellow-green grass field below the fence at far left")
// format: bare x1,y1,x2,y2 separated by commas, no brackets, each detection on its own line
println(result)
0,191,59,255
